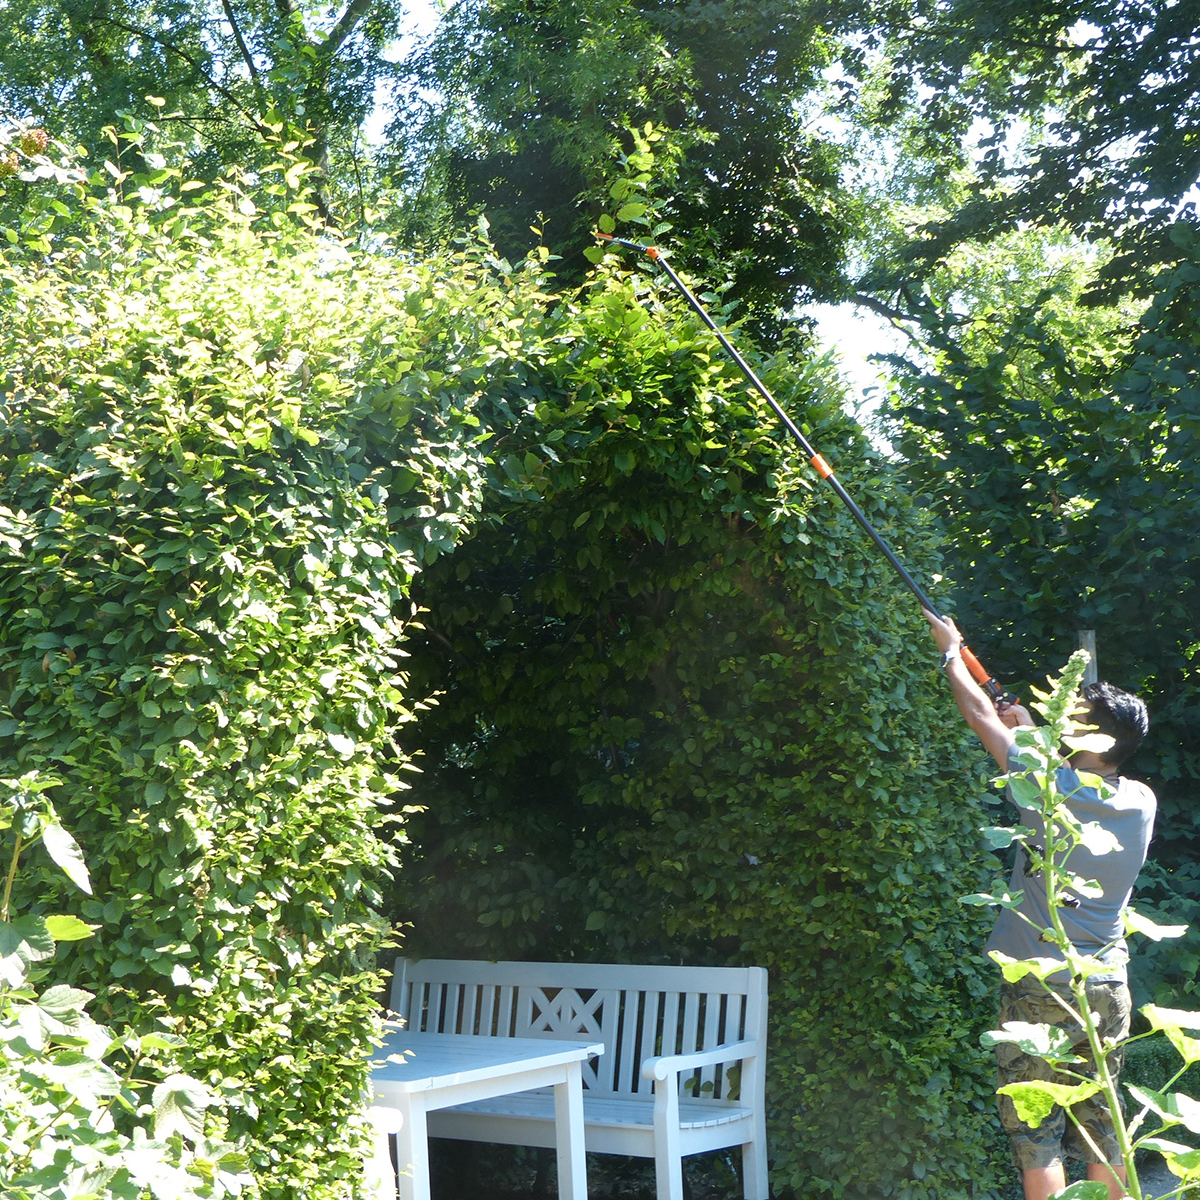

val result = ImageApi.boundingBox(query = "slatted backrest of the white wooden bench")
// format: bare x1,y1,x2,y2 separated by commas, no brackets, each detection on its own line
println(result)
391,959,767,1100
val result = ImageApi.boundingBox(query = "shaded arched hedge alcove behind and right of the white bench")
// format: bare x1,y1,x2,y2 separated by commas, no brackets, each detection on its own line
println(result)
395,253,1008,1200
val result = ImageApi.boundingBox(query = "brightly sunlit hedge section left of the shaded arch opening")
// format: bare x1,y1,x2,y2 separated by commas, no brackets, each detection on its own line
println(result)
0,124,549,1200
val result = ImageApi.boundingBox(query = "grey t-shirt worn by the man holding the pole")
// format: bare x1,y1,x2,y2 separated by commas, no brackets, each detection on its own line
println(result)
986,746,1157,980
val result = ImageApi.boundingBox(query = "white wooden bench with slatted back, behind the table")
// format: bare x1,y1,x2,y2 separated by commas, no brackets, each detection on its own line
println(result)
391,959,767,1200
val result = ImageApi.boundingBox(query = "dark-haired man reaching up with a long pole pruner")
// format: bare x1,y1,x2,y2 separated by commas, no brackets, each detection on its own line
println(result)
925,611,1156,1200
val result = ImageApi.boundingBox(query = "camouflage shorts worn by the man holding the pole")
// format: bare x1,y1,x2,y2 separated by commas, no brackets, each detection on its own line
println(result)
996,976,1130,1171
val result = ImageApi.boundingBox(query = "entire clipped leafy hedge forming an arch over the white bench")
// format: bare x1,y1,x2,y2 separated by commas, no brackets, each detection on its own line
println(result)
0,124,1012,1200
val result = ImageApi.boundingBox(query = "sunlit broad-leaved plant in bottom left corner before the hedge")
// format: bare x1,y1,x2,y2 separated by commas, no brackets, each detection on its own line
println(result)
0,772,251,1200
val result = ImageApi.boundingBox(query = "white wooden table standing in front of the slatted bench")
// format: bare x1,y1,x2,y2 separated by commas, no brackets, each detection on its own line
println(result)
367,1030,604,1200
